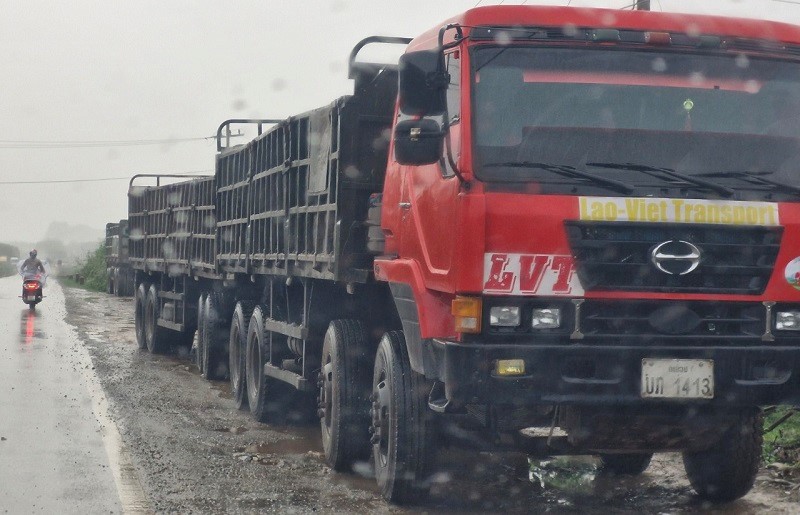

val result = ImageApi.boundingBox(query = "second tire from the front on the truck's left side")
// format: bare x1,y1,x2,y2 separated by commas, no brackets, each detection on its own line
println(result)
317,320,372,471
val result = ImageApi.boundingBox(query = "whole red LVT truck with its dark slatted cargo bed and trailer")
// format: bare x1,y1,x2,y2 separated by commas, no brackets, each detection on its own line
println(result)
128,6,800,502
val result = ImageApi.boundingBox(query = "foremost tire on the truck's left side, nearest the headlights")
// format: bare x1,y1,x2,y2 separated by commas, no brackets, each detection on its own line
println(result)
371,331,434,503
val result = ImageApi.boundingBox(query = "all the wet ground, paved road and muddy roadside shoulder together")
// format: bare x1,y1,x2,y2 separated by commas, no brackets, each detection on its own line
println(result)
0,278,798,514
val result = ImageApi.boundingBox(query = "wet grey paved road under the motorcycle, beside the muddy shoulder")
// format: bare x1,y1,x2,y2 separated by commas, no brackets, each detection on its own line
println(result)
0,277,147,513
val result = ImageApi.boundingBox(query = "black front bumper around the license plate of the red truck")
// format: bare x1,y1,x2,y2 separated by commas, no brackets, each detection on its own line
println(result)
424,339,800,406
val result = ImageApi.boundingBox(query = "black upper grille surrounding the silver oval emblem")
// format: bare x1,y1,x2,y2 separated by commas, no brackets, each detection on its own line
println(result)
564,221,783,295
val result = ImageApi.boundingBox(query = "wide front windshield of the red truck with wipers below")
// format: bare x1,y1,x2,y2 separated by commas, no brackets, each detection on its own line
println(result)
472,46,800,194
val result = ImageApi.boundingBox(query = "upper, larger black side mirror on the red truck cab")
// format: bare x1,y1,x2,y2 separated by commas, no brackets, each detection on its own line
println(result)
399,50,450,116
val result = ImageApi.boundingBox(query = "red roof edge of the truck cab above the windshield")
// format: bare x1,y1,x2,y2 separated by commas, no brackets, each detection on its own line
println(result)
408,5,800,51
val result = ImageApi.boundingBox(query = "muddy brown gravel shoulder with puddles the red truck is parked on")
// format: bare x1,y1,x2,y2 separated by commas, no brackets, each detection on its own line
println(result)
65,288,800,514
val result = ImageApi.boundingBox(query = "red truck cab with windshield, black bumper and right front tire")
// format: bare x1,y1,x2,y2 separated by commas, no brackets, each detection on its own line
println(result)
374,6,800,500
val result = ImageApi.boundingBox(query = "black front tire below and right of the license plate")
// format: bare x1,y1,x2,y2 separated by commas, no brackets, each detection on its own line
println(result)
683,408,763,502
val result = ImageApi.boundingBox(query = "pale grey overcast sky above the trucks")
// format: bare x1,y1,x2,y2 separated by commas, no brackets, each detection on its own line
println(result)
0,0,800,242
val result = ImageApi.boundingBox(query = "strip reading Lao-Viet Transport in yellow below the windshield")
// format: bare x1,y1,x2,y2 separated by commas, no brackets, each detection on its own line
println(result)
578,197,780,225
